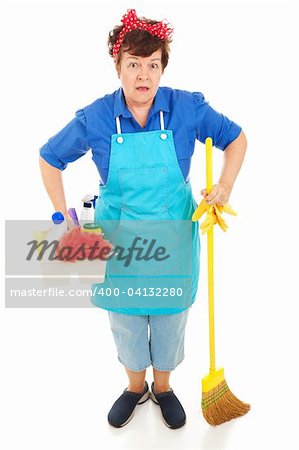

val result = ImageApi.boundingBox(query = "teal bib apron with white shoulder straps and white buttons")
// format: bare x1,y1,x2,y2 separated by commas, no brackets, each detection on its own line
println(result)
92,111,200,315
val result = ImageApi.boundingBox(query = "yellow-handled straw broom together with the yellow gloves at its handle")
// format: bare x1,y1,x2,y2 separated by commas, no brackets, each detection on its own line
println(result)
192,138,250,425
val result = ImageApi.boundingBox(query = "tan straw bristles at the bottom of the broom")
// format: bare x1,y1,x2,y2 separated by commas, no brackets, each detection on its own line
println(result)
201,380,250,425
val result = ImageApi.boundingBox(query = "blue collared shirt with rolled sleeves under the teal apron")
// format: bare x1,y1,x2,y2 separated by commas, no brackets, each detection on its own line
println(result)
40,87,241,184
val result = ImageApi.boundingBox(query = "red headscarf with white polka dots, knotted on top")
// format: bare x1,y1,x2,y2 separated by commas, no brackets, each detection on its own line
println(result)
113,9,173,58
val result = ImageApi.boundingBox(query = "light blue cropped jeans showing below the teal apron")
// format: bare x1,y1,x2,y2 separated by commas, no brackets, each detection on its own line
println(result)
108,309,189,372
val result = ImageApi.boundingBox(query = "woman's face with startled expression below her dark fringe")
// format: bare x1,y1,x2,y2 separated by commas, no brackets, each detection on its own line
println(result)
116,49,163,106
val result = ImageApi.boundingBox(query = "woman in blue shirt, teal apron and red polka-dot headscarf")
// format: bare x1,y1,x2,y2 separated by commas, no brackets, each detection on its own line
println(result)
40,10,246,429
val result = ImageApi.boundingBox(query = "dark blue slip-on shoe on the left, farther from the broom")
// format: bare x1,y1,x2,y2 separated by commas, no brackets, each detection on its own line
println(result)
108,382,150,428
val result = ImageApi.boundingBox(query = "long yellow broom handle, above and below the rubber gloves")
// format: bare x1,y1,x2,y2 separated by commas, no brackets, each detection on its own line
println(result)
205,138,216,373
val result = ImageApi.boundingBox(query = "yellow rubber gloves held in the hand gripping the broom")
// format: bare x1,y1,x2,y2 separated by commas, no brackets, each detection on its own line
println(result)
192,198,237,234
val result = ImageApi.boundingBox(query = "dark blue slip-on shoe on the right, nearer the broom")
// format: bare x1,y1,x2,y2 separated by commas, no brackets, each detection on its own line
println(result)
150,383,186,429
